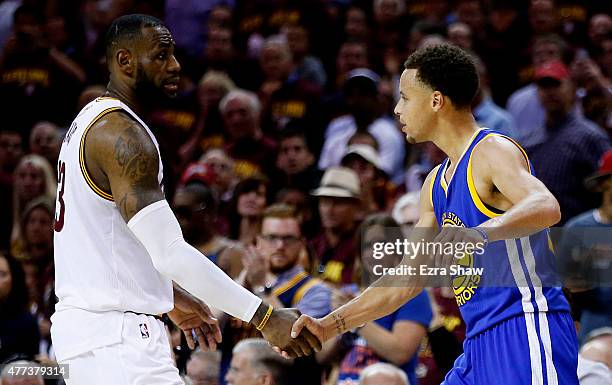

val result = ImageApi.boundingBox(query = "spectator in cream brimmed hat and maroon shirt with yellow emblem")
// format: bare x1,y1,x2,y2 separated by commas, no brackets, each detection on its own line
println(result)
311,167,361,285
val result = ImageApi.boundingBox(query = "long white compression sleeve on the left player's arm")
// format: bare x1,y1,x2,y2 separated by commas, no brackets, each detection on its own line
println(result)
128,200,261,322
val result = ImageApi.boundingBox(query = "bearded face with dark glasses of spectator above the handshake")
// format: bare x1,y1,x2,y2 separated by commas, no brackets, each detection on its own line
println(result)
257,217,303,274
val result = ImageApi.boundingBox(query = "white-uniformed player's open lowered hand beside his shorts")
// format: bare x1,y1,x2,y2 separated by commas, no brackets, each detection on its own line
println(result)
168,287,221,351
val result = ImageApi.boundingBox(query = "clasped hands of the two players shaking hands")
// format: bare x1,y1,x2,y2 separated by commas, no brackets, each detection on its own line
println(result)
251,304,326,358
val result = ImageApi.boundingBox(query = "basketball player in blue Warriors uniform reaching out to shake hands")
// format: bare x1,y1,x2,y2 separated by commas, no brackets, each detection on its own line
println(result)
292,45,578,385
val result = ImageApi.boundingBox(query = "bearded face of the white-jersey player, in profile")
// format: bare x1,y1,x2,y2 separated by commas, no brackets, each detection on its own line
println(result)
135,26,181,101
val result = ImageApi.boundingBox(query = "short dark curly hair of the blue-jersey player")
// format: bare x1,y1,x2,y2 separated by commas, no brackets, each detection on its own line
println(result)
404,44,478,109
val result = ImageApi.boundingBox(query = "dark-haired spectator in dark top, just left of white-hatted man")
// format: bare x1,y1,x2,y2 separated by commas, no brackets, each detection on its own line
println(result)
272,124,323,192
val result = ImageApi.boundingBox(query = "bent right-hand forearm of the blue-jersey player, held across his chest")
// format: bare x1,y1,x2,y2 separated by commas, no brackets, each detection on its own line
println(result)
478,193,561,242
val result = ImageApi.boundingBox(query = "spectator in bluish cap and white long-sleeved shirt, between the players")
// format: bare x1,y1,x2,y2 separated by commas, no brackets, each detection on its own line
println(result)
319,68,405,183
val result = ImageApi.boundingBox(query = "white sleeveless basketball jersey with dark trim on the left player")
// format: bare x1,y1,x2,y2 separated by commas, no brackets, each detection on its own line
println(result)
54,97,173,314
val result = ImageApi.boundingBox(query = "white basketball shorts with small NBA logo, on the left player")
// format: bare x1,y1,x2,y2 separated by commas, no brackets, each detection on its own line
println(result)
61,313,184,385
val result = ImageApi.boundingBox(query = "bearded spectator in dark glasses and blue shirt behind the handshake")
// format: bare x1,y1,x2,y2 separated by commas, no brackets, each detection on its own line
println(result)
245,203,331,317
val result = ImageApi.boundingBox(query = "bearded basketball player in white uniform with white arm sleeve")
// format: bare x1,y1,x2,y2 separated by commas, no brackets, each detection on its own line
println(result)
51,15,319,385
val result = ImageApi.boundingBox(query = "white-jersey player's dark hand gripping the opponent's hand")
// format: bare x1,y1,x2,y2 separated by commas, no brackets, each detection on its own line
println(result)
261,309,321,358
